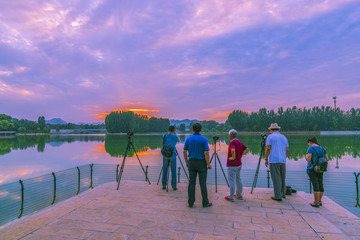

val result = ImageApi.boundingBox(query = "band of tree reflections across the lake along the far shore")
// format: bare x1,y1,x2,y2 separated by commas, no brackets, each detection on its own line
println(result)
0,134,360,161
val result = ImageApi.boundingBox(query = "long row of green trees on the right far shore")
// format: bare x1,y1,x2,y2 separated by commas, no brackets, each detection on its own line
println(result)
228,106,360,131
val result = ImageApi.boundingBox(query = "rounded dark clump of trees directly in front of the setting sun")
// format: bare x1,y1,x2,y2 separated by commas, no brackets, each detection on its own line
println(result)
105,111,170,133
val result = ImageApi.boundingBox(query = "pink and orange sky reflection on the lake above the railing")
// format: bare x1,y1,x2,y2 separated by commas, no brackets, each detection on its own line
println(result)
0,136,360,184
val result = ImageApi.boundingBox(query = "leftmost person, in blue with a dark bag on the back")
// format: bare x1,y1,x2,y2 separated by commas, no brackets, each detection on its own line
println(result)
161,126,180,191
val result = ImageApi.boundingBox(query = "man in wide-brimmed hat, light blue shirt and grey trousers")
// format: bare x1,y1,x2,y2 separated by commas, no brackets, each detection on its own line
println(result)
265,123,289,201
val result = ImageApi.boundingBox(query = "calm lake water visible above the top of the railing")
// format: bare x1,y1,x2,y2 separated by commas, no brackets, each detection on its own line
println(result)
0,135,360,184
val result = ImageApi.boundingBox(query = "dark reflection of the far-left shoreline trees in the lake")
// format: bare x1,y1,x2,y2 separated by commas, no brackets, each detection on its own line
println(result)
0,135,105,155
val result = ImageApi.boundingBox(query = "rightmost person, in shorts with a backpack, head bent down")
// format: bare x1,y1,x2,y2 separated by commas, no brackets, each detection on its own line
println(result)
305,137,329,207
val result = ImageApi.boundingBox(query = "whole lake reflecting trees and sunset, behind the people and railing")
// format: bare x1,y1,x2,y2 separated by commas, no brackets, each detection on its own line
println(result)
0,134,360,225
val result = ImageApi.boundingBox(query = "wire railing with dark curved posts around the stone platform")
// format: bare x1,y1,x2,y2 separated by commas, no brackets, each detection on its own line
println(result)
0,164,360,226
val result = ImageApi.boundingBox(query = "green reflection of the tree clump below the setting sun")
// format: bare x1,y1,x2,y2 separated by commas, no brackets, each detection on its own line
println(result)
105,134,162,157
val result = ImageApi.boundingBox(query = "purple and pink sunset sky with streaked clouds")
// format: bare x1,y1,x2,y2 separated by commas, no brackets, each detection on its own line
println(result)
0,0,360,122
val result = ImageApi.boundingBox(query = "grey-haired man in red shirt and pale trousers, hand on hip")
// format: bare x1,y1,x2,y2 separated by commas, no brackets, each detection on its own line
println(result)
225,129,248,202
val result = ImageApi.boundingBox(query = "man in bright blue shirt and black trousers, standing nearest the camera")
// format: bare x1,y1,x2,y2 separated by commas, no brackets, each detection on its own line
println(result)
183,123,212,207
